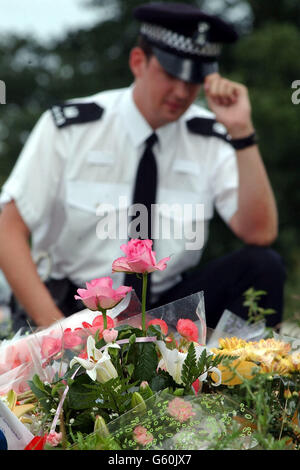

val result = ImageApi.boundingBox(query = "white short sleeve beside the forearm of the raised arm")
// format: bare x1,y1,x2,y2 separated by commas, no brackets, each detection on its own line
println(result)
211,141,239,223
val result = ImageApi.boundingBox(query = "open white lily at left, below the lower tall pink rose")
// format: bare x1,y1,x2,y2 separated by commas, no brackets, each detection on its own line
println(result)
70,336,119,383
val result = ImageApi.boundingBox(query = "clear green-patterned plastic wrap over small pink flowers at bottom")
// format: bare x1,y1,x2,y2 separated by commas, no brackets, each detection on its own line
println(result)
79,391,256,450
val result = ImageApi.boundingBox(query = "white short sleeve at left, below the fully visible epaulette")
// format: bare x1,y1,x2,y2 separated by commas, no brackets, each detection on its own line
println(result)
0,111,66,231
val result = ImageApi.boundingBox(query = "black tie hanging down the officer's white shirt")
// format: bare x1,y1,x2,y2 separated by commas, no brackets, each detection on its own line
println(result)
124,133,158,300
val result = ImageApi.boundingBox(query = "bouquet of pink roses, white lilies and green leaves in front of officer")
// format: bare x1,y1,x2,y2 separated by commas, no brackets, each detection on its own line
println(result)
2,240,222,447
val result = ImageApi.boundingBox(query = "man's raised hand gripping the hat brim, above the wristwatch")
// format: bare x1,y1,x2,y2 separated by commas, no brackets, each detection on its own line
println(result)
204,73,254,139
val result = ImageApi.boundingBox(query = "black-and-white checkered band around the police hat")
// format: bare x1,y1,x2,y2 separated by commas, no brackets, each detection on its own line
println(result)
140,23,221,57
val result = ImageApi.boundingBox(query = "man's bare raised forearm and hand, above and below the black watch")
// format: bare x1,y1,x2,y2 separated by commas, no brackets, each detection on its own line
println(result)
204,73,277,245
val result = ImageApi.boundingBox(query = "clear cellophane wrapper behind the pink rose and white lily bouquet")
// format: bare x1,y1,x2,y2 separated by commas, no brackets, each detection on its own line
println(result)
0,292,206,395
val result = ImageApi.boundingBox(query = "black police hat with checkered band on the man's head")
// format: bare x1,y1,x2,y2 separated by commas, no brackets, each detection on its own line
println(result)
133,2,238,83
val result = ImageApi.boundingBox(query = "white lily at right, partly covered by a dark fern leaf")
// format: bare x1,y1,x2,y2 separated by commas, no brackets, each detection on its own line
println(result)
156,341,221,386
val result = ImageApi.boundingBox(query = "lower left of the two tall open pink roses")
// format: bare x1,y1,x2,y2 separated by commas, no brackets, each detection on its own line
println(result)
75,277,132,310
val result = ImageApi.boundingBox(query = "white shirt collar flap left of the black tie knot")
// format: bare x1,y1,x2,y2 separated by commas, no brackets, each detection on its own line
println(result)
121,86,153,147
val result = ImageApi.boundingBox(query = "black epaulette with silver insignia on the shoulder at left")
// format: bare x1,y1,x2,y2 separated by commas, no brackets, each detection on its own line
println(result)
51,103,104,128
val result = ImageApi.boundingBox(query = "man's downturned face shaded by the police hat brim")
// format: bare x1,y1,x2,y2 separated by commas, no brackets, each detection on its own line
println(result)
133,52,200,129
